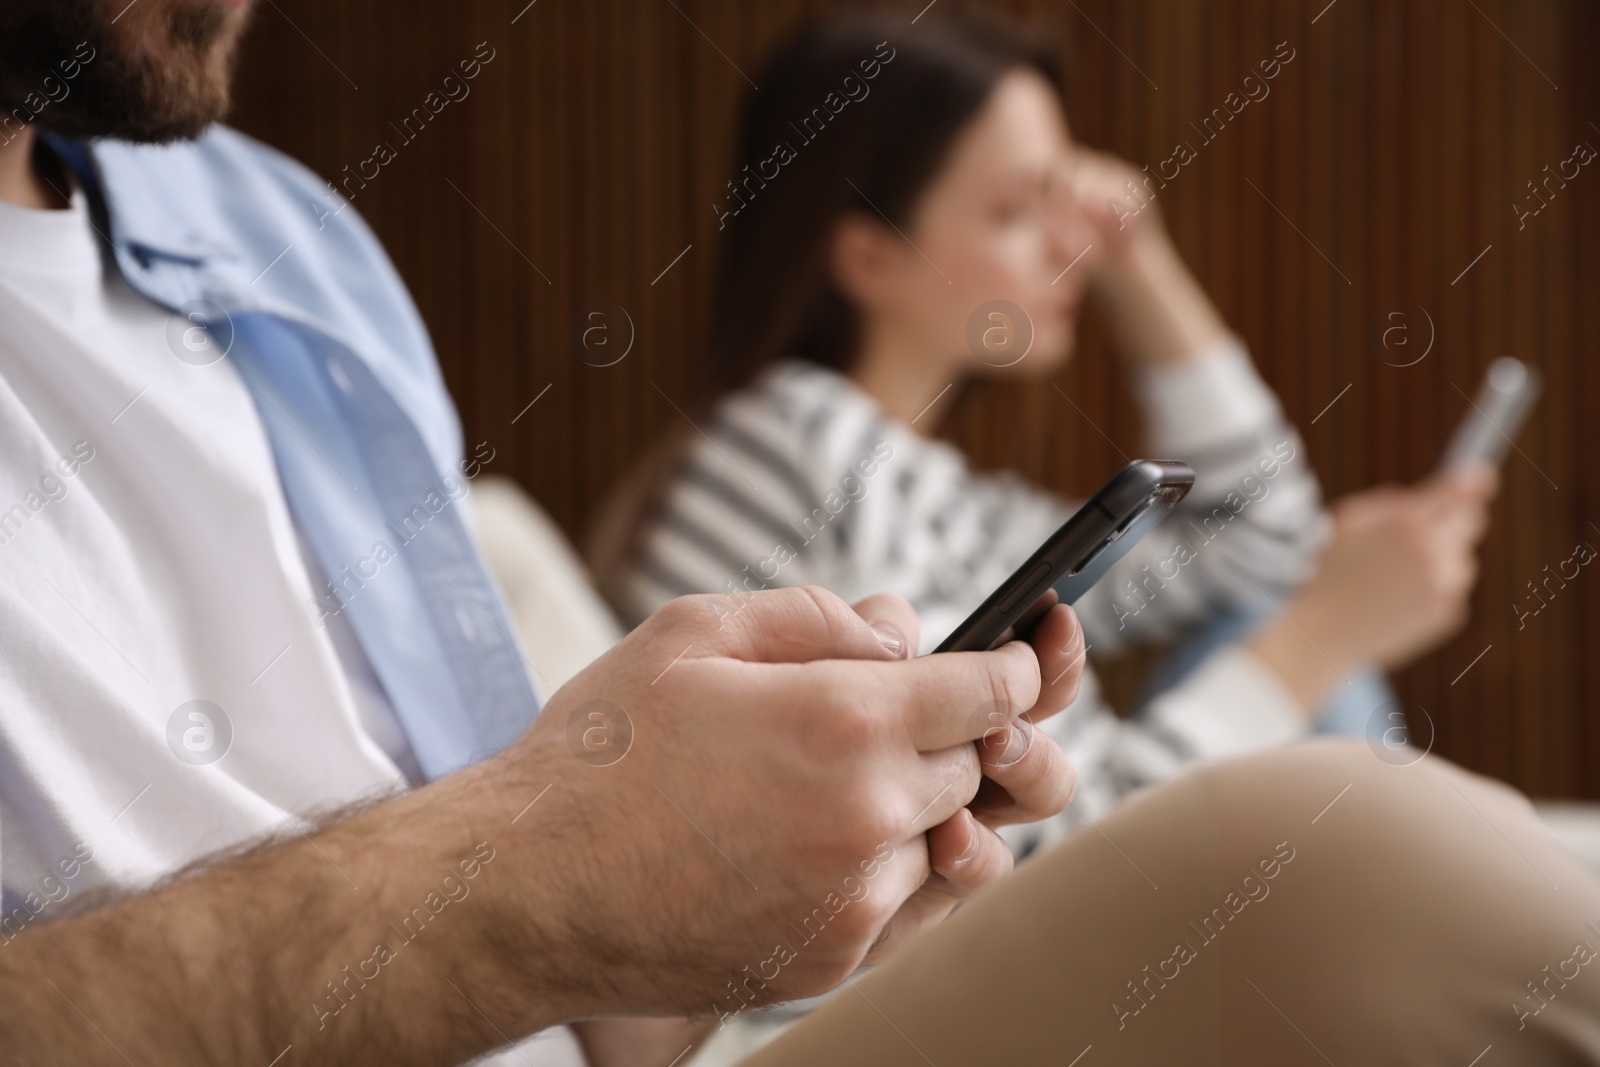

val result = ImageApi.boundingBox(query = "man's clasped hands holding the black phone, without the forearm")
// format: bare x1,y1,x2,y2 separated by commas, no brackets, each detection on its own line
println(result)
498,589,1082,1016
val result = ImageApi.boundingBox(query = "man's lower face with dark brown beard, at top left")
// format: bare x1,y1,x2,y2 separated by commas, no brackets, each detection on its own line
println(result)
0,0,245,142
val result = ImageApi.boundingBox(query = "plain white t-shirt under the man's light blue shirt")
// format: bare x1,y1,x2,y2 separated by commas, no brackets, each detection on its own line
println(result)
0,197,574,1064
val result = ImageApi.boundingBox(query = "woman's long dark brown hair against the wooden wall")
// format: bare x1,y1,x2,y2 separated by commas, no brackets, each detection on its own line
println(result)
712,11,1061,392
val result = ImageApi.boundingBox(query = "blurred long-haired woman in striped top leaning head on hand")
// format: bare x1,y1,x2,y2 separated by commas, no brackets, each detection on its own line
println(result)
597,14,1490,851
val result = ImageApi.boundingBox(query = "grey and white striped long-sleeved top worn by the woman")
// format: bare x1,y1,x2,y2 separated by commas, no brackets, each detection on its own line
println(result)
613,339,1326,851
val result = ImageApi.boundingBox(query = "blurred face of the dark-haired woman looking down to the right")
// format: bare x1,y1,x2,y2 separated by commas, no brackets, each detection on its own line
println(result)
862,70,1091,376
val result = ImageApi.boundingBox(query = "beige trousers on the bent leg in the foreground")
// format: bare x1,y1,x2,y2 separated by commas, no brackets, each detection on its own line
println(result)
742,741,1600,1067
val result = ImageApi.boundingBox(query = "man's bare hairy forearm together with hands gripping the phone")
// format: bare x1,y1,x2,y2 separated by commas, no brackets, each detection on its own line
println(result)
0,589,1082,1064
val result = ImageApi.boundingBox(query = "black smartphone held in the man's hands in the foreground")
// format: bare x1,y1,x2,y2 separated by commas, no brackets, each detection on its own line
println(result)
933,459,1195,653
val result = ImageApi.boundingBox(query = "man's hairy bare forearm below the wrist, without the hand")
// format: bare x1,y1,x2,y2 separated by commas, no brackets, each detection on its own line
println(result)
0,761,579,1065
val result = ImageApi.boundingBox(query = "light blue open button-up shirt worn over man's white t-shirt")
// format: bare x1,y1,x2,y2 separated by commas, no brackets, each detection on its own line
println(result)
46,126,539,779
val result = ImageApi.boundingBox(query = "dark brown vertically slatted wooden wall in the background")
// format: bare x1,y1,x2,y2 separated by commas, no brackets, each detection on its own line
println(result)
235,0,1600,797
